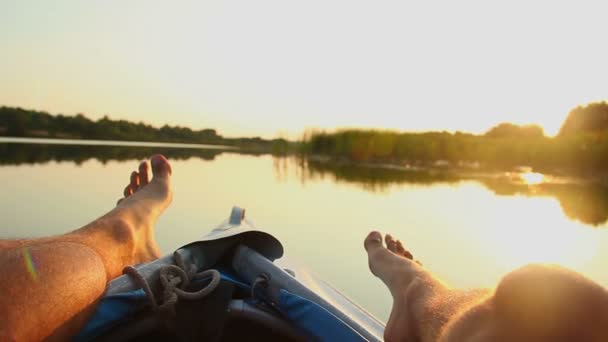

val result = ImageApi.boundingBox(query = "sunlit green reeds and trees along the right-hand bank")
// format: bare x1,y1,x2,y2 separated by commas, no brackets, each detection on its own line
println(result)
302,102,608,175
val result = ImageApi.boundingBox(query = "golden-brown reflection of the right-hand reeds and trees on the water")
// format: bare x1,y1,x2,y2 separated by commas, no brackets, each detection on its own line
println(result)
288,158,608,227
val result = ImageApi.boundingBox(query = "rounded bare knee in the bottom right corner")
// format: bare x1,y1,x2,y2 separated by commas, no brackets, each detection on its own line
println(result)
493,264,608,340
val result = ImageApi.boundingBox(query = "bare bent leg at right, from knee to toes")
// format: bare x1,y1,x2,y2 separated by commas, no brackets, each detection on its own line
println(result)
365,232,608,342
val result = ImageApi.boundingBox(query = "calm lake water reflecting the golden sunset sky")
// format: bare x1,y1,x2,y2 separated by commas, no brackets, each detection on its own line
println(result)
0,139,608,320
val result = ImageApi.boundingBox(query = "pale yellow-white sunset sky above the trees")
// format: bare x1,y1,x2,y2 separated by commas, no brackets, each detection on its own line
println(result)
0,0,608,137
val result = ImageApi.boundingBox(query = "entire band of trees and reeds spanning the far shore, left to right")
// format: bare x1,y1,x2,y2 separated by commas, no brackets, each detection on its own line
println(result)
0,102,608,172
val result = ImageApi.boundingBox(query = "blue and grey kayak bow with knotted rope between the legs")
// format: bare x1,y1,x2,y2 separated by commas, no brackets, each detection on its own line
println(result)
75,207,384,341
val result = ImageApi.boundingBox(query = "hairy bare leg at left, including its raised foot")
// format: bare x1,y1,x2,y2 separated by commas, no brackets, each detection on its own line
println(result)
0,156,172,341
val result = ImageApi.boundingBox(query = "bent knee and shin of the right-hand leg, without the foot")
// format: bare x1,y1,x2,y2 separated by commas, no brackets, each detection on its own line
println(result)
444,264,608,342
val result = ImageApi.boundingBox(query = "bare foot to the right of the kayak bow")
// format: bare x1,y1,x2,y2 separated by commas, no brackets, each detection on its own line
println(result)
364,231,448,341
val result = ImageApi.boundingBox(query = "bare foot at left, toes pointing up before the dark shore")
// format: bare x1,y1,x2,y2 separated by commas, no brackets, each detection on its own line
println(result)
108,155,173,262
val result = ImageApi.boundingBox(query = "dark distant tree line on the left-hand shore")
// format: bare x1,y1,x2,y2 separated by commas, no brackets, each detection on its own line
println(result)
0,106,293,153
